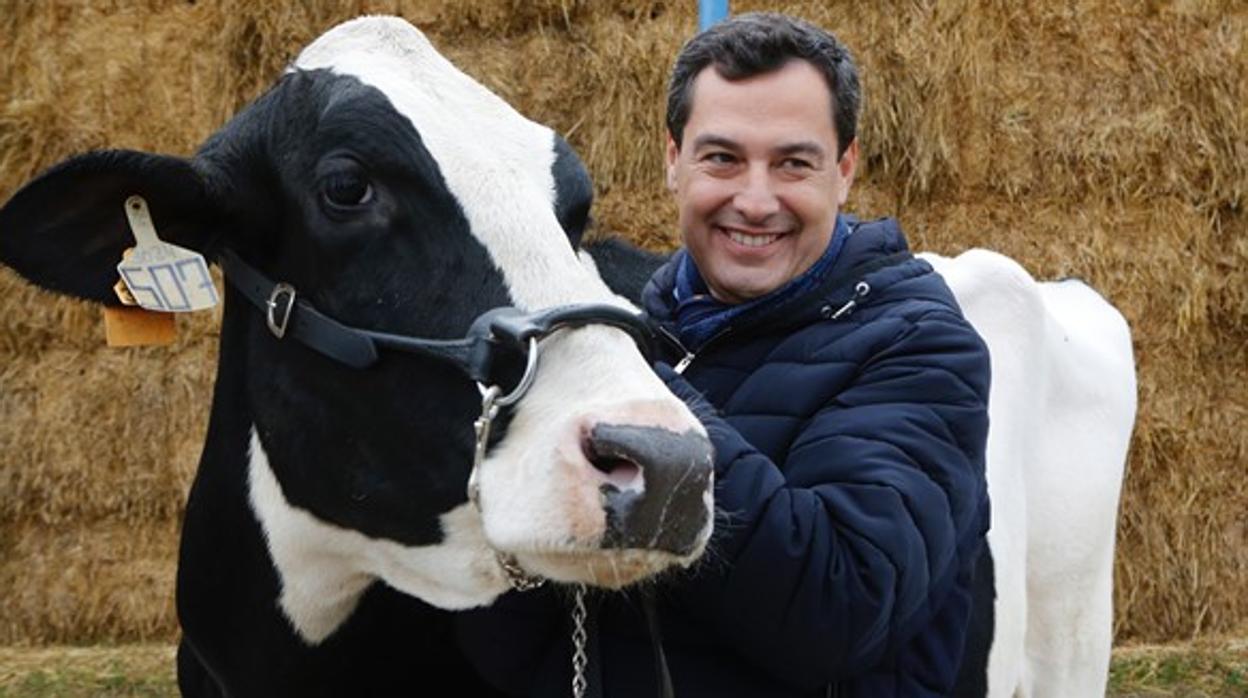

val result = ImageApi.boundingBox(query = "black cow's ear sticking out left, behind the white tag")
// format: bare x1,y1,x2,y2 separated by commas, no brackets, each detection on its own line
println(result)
0,150,217,305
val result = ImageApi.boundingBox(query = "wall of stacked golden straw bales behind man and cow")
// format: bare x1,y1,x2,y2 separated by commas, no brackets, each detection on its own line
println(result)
0,0,1248,643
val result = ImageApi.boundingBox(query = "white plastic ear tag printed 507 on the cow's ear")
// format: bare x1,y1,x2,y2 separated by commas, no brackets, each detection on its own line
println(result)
117,195,218,312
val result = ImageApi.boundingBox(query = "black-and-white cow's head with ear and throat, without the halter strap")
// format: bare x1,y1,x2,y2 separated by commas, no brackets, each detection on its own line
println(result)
0,17,710,637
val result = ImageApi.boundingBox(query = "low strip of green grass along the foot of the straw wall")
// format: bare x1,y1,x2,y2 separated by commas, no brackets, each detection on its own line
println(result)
0,641,1248,698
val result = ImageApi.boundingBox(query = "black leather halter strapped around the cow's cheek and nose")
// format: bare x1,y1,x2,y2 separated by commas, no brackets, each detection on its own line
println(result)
221,250,653,385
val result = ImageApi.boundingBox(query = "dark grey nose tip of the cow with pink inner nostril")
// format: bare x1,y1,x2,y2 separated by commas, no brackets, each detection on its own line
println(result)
583,423,713,554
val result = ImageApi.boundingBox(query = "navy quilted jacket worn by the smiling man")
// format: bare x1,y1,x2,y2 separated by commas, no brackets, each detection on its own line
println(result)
461,220,988,698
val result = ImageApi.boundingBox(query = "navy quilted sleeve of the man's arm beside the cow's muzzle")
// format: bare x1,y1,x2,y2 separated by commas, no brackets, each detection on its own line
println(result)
659,311,988,687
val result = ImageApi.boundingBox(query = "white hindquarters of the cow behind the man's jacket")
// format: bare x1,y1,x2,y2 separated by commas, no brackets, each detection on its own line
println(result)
921,250,1136,697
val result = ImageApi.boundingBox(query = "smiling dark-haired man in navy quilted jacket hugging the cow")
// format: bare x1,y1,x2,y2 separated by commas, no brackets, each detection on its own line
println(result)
462,14,988,698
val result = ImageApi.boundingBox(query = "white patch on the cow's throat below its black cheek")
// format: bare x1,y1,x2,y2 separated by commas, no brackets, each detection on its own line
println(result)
248,428,507,644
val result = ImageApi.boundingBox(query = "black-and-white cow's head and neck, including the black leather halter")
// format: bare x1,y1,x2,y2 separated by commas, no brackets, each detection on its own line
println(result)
0,17,713,696
